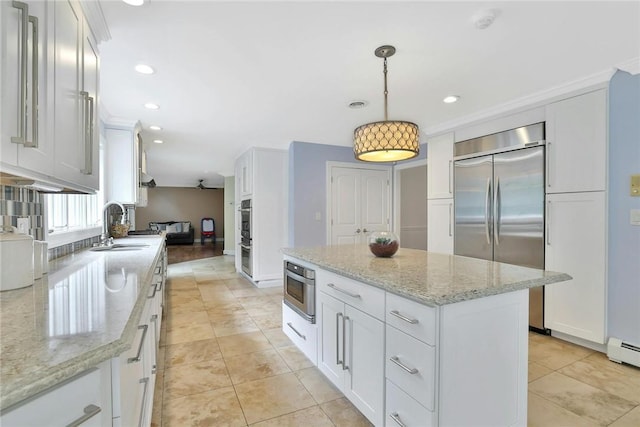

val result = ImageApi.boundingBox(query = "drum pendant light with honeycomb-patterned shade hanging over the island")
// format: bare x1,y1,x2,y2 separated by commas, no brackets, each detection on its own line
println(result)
353,45,420,162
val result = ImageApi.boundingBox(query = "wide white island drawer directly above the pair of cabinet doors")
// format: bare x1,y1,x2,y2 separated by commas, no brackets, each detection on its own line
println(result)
316,270,385,320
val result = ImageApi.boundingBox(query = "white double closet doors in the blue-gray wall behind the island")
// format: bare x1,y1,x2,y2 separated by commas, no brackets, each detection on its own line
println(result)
328,166,390,245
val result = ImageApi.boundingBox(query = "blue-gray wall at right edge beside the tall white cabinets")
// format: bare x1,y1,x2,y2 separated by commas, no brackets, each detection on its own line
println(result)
608,71,640,345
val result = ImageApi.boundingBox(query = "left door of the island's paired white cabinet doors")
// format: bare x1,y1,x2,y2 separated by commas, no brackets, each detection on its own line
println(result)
316,292,345,390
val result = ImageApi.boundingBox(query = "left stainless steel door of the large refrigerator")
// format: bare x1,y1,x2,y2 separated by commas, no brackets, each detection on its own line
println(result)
453,156,493,260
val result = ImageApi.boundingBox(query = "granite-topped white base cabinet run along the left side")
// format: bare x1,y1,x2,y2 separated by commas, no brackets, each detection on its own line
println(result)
0,235,166,425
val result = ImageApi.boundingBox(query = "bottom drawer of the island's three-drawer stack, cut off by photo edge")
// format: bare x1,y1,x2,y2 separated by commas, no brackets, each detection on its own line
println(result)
384,380,435,427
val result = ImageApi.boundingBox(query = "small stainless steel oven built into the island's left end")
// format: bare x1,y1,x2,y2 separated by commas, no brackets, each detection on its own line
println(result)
284,261,316,323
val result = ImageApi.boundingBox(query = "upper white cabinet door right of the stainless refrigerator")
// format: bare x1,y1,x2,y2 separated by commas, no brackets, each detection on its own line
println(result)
545,89,607,194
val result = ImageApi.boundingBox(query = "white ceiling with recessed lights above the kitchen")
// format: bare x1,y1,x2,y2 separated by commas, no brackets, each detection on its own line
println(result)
99,0,640,187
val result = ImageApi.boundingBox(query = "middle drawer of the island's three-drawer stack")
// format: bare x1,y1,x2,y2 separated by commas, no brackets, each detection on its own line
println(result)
385,325,435,410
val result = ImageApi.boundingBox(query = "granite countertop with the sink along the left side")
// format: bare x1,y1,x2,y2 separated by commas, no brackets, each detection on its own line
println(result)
0,235,164,409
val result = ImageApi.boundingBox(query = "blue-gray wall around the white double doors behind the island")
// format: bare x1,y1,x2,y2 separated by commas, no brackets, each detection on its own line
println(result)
289,141,427,247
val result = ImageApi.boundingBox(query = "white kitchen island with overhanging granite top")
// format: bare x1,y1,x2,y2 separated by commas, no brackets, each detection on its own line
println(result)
283,245,571,426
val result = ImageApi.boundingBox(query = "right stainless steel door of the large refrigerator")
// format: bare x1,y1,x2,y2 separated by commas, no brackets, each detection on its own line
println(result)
493,147,544,268
